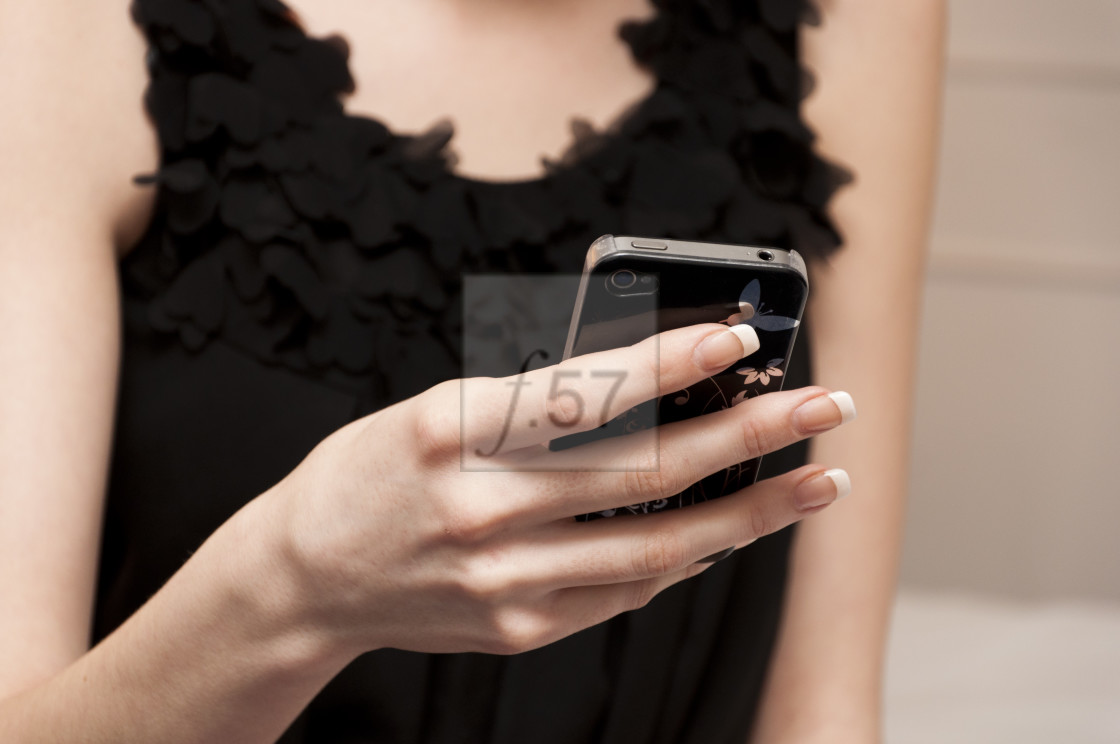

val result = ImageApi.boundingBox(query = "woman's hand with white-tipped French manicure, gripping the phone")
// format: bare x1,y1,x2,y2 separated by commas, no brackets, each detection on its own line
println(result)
262,325,853,655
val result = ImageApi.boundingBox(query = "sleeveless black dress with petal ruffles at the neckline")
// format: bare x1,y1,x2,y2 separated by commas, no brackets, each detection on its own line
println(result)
95,0,843,744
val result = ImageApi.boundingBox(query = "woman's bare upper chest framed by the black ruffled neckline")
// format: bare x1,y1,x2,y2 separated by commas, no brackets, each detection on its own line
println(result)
288,0,656,180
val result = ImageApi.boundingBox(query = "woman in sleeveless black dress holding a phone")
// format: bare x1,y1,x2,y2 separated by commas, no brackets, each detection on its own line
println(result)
0,0,941,742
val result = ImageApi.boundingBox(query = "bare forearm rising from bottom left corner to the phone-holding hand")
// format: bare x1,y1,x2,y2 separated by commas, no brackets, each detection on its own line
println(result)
0,493,349,744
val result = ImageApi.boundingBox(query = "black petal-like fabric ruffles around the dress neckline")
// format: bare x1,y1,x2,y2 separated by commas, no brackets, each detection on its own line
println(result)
122,0,844,407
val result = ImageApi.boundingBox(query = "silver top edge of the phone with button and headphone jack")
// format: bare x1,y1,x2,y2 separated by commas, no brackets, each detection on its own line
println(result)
585,235,809,287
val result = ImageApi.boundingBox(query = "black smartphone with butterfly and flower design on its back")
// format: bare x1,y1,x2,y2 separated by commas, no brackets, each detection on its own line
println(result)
550,235,809,521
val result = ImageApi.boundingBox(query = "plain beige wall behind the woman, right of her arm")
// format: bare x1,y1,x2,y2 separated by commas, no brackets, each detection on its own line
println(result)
903,0,1120,601
